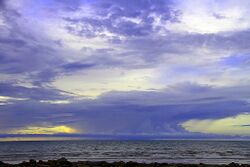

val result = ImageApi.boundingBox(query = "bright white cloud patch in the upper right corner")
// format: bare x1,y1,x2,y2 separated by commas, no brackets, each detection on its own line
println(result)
166,0,250,34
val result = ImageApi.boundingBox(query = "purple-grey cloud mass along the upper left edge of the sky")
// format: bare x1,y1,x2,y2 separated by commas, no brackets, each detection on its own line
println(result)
0,1,66,86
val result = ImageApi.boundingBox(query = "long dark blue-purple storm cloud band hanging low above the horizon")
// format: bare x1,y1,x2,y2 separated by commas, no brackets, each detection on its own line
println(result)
0,82,250,137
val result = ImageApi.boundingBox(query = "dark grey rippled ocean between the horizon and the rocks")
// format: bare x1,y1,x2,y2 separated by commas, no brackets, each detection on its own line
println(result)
0,140,250,164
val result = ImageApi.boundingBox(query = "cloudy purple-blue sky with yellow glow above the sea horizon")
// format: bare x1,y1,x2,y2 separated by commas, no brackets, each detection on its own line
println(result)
0,0,250,140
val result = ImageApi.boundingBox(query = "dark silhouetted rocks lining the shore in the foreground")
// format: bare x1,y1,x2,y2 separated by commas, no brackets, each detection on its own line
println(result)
0,158,250,167
